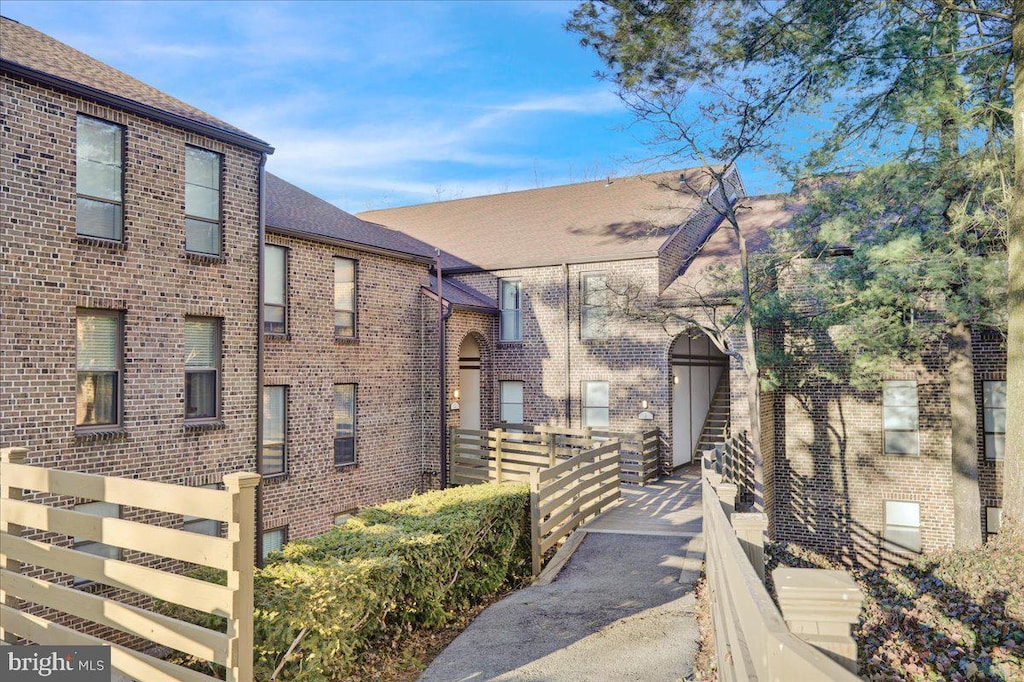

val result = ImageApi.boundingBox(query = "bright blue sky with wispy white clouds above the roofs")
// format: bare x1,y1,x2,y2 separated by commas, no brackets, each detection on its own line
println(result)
3,0,781,212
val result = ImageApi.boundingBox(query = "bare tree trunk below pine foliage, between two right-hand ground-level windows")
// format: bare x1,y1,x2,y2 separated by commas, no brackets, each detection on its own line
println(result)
949,324,981,549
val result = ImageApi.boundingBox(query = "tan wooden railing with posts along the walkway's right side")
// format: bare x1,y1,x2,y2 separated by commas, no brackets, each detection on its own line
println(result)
702,450,862,682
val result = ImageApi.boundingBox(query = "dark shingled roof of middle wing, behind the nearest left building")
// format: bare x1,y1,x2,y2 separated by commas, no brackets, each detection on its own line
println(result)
266,173,434,262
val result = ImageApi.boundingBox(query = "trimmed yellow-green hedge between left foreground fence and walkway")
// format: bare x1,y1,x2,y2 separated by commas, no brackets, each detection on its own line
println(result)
161,483,529,681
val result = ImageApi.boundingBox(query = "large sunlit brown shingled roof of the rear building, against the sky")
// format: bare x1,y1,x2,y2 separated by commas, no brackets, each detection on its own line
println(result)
358,169,709,271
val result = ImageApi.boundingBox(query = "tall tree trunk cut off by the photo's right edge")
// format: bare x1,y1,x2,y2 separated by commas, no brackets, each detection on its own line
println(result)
1002,0,1024,537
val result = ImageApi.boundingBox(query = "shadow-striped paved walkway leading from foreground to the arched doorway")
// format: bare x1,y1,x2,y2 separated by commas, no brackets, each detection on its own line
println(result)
420,466,702,682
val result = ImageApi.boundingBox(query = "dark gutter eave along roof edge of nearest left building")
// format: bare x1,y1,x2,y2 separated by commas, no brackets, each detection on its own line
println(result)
0,59,273,154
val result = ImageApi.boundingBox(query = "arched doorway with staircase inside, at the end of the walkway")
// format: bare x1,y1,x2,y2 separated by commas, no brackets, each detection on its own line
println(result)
669,330,729,467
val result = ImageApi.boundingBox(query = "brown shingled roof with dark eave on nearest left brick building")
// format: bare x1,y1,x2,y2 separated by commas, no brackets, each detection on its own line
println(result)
0,16,273,153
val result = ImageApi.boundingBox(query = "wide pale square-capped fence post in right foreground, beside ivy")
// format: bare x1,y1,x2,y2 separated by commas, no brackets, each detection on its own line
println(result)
772,566,864,674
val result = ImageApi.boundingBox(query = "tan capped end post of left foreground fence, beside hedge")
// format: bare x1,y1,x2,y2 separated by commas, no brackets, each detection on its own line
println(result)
223,472,262,682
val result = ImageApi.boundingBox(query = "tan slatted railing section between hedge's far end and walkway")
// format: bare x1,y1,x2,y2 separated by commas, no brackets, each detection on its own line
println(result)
529,440,620,576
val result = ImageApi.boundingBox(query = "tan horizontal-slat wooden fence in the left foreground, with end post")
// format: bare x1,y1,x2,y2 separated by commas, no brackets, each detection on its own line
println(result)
0,447,260,682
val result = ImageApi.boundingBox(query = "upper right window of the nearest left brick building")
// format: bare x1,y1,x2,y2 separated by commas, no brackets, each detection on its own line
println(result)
185,146,221,256
